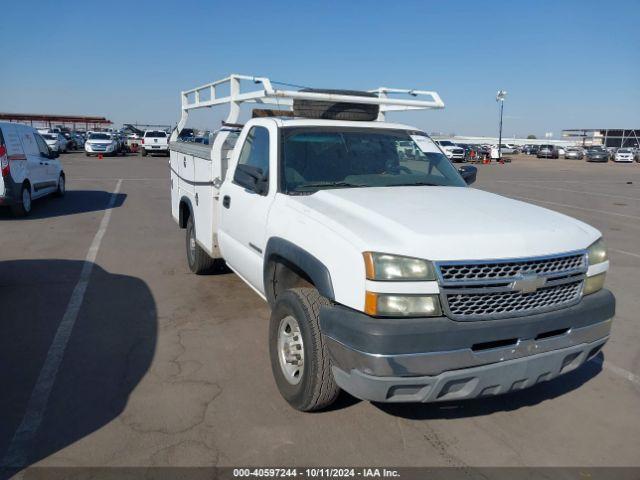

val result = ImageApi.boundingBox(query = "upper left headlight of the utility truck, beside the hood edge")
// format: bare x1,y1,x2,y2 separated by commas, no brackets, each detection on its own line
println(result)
362,252,436,282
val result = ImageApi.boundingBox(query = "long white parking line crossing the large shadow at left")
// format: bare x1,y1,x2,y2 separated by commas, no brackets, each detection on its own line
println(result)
0,179,122,467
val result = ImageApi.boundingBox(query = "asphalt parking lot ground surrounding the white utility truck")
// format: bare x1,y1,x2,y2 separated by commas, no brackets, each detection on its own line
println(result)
0,154,640,467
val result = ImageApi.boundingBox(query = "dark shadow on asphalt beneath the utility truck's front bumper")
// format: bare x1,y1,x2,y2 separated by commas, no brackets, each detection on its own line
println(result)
372,352,603,420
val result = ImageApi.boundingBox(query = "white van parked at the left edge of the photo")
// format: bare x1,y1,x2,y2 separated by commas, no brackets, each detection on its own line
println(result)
0,122,65,217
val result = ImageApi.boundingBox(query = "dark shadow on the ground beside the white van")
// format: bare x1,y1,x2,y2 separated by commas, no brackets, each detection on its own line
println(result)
0,190,127,222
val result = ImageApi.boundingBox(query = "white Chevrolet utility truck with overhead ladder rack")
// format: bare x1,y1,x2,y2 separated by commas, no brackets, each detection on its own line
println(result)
170,75,615,411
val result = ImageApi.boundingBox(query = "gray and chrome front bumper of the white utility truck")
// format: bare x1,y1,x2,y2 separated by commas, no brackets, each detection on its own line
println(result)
320,290,615,402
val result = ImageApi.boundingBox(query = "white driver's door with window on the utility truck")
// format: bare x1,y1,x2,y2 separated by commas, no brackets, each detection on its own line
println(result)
218,125,277,292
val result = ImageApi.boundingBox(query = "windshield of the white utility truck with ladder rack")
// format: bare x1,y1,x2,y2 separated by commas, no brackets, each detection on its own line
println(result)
282,128,466,194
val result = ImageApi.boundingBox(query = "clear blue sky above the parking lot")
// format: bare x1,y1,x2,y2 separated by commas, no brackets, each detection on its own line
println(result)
0,0,640,138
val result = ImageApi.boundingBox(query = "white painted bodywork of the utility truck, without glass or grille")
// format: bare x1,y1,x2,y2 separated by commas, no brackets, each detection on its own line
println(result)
171,118,608,311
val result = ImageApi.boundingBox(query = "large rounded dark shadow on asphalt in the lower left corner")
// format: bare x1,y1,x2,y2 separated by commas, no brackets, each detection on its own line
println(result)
0,259,158,479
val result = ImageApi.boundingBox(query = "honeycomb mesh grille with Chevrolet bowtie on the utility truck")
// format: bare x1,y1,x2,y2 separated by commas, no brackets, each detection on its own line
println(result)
436,252,587,320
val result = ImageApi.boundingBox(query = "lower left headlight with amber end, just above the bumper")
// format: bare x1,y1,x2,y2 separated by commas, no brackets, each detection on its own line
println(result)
364,292,442,317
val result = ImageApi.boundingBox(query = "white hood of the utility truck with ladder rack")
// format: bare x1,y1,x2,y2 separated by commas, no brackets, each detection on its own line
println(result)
288,186,601,260
